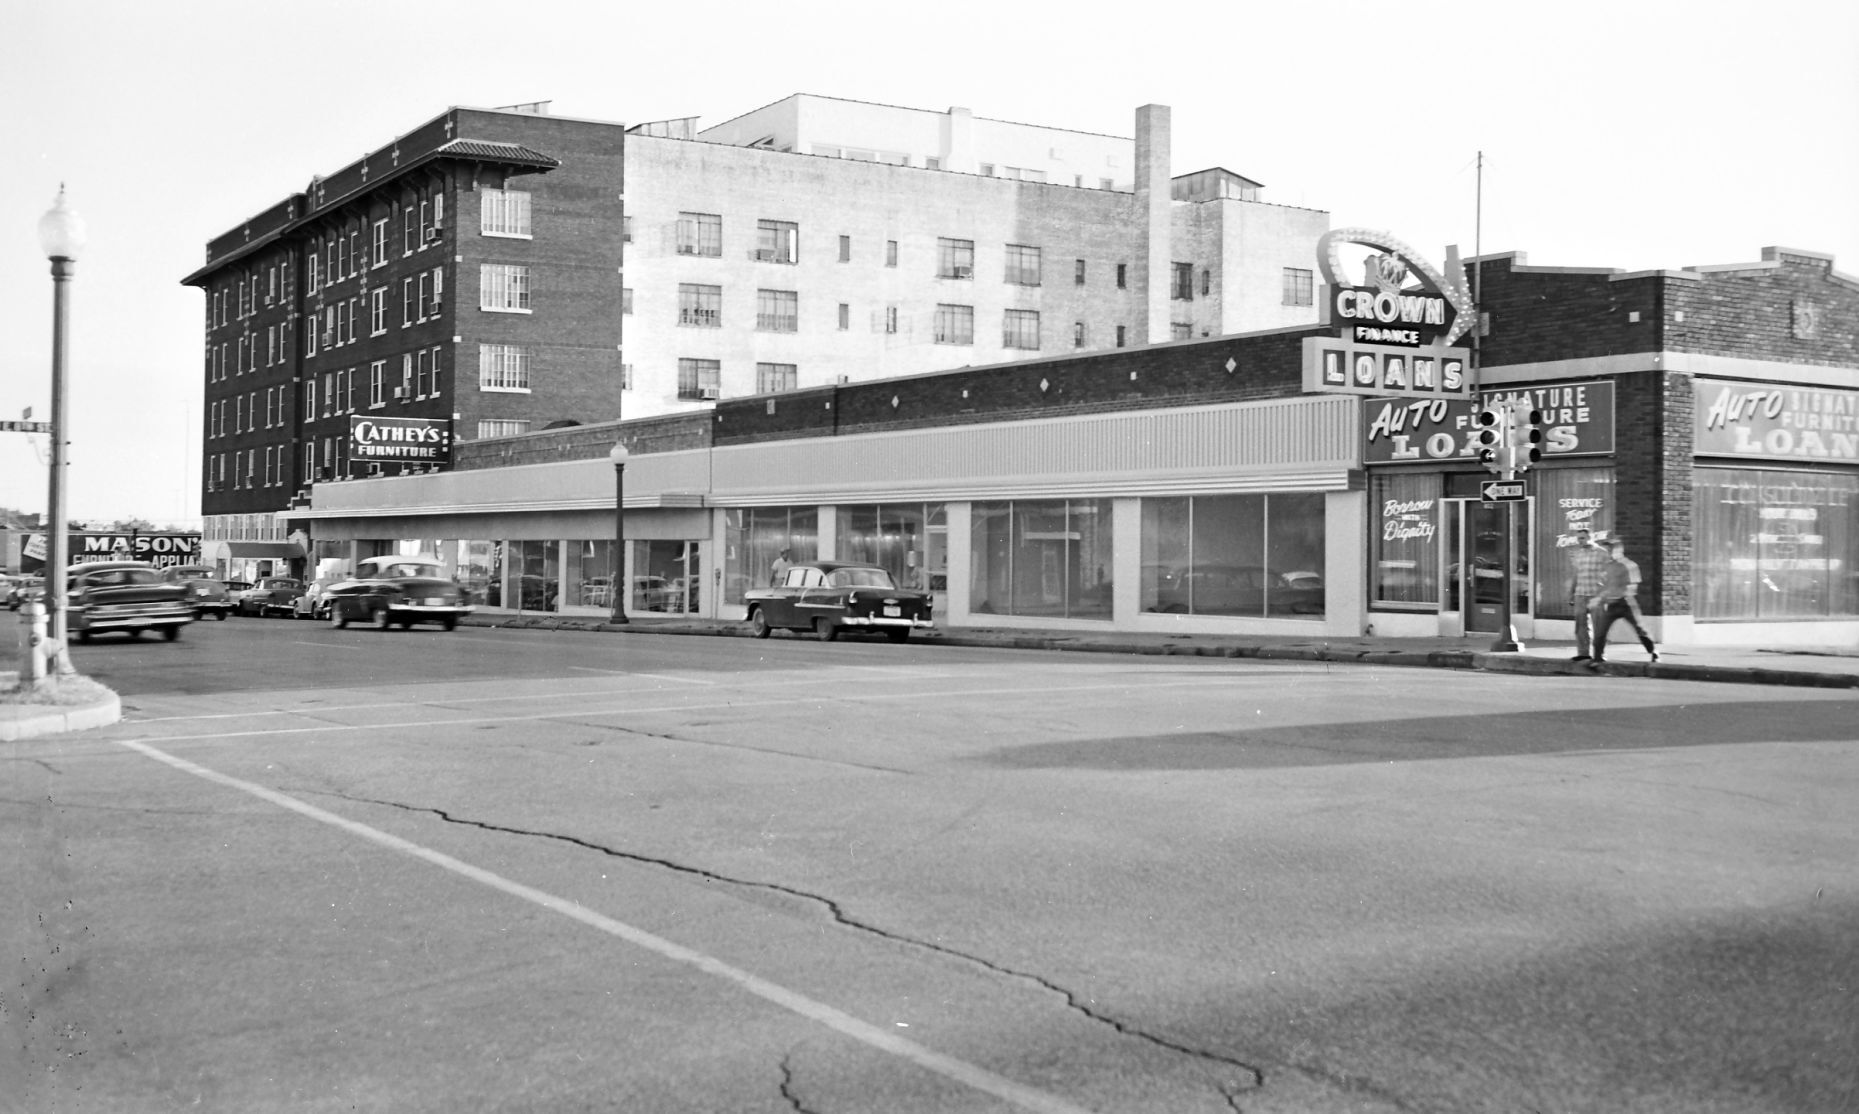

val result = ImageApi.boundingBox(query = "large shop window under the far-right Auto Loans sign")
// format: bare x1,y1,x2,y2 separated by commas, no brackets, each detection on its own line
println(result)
1692,461,1859,619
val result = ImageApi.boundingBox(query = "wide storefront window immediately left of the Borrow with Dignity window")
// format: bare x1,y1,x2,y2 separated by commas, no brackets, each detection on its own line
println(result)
1140,495,1324,619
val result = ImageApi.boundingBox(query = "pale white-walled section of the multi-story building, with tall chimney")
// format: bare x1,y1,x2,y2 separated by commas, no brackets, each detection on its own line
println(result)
625,95,1329,417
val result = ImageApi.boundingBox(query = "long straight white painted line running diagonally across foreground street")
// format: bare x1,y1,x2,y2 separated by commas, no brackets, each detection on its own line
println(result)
119,740,1089,1114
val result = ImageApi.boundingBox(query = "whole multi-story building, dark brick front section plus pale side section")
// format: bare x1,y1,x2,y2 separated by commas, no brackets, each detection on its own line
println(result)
184,97,1327,573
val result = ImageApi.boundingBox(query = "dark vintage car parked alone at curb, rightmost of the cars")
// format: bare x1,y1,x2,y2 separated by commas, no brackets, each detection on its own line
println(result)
744,562,935,642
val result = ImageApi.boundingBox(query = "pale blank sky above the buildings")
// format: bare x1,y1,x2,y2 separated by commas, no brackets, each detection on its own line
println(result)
0,0,1859,526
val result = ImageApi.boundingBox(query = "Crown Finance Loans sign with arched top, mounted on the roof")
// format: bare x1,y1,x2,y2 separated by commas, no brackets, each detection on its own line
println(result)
1303,229,1474,398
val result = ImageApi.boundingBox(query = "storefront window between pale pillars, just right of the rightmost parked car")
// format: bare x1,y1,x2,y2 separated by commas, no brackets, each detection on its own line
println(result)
969,498,1112,619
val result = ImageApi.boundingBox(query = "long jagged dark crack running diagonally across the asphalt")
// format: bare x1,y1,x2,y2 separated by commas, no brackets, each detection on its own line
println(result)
329,792,1266,1110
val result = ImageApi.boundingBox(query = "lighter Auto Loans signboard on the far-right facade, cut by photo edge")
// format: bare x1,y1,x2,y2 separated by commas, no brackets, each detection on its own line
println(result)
1694,378,1859,465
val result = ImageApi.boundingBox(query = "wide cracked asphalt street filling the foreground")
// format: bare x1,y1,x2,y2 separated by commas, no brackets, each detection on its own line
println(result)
0,619,1859,1114
